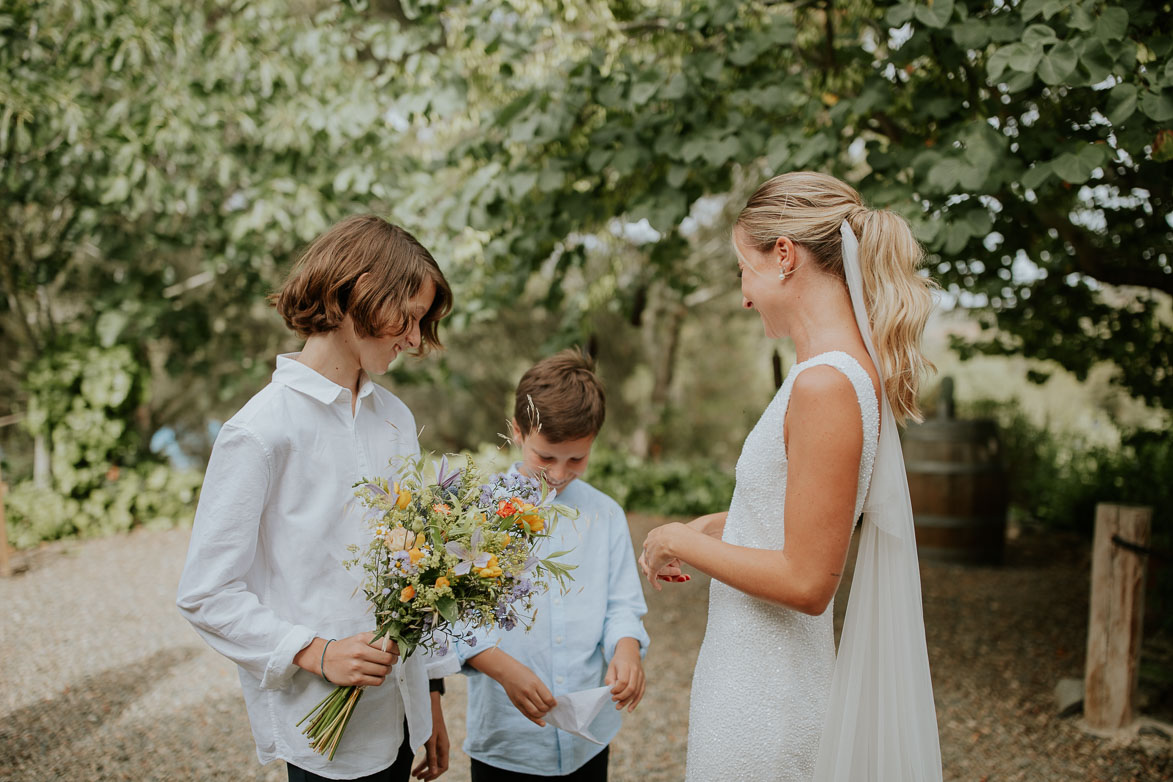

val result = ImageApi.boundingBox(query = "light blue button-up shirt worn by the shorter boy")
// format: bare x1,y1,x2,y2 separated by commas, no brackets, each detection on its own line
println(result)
455,471,649,776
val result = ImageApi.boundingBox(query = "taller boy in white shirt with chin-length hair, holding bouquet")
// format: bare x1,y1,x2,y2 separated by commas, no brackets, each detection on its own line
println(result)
177,216,456,782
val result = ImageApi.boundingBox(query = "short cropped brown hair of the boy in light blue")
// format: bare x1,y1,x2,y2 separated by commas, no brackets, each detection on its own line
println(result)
514,348,606,443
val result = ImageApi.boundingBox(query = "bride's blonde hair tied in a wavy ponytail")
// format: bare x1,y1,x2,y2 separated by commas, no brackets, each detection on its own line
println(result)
735,171,936,424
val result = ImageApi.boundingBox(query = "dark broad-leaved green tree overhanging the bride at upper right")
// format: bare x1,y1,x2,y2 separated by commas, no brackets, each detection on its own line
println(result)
408,0,1173,422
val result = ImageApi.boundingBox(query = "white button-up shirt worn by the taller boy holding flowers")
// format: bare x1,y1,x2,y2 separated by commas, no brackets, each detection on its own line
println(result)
176,354,457,778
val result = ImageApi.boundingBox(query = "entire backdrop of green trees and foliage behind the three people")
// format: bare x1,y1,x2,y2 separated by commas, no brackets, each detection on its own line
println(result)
0,0,1173,628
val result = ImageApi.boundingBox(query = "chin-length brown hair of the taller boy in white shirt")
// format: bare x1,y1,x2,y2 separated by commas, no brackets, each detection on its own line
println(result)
269,215,452,354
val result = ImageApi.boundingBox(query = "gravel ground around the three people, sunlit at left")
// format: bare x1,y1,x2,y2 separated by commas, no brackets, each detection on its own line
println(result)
0,517,1173,782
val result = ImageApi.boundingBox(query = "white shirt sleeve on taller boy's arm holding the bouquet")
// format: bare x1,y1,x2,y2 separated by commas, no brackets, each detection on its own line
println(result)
176,423,314,689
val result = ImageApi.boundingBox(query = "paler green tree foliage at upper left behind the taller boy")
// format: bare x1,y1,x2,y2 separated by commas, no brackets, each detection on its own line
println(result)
0,0,433,480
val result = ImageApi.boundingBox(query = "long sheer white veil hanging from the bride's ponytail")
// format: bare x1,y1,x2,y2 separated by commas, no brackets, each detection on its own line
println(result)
814,220,942,782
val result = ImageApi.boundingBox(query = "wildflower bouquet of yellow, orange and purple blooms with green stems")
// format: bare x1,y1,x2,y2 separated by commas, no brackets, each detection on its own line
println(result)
298,456,576,760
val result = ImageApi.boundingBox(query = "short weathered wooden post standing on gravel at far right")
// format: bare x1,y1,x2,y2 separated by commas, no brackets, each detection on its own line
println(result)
1084,503,1153,730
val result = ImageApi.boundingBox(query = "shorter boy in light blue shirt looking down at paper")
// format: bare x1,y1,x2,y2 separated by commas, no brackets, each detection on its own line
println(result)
456,351,649,782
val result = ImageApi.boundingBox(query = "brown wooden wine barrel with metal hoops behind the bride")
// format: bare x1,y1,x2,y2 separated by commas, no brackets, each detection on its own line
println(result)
902,408,1008,564
